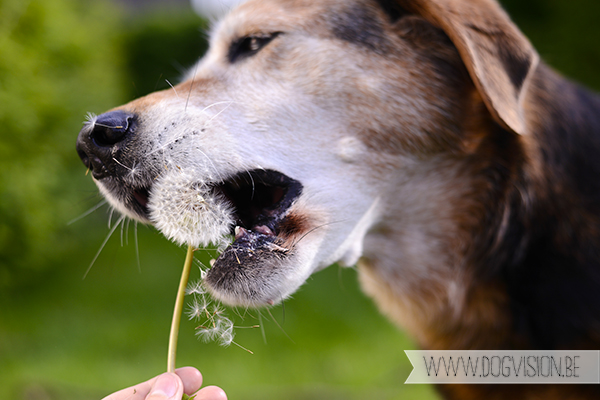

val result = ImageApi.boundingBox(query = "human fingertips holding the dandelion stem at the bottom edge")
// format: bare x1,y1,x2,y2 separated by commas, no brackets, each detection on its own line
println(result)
102,367,227,400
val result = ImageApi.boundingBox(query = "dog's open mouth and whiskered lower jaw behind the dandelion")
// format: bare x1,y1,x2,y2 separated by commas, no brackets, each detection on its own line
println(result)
129,170,309,306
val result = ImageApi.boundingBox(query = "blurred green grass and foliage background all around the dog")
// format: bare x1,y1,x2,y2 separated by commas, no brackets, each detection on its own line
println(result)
0,0,600,400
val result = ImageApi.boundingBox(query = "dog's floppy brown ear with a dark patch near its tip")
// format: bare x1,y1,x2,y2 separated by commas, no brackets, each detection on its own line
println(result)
396,0,539,134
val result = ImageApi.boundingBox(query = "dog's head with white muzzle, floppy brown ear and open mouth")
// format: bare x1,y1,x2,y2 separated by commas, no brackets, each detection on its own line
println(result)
77,0,537,306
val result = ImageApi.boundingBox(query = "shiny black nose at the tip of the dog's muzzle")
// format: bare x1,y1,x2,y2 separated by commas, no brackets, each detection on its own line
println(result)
77,111,136,179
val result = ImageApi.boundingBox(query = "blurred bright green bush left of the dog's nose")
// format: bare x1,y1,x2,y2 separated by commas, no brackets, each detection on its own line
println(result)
0,0,123,290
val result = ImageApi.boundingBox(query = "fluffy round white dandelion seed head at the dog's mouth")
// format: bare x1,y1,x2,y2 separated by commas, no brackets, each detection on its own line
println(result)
148,168,234,247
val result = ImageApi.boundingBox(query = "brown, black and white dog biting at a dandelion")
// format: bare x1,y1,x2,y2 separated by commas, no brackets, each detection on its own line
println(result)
77,0,600,399
